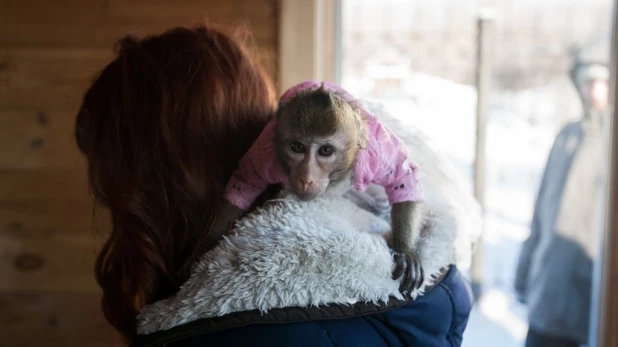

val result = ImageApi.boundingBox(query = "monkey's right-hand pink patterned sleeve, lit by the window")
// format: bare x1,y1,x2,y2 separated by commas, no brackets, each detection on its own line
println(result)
355,117,425,205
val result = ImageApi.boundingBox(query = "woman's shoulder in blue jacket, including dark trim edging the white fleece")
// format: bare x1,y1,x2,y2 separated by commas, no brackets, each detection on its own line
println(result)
135,267,472,347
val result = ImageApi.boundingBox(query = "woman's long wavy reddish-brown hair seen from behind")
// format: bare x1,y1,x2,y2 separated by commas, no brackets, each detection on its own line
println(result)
76,27,275,338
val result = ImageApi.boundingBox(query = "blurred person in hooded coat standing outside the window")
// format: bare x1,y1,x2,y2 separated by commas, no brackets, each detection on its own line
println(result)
515,37,610,347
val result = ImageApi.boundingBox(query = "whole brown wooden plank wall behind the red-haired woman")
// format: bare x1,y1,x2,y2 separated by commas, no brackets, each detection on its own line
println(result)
0,0,278,346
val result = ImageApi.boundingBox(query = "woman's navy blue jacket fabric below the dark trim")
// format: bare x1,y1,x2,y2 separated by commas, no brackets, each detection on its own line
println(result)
136,267,473,347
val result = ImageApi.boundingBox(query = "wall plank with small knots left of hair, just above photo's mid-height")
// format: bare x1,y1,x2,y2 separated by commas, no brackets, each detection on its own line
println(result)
0,110,86,170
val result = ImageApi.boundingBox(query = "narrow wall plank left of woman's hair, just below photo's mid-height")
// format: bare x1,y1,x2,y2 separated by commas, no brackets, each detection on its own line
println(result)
0,169,91,205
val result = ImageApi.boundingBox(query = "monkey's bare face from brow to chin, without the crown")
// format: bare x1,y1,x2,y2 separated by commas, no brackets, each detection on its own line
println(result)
279,136,355,201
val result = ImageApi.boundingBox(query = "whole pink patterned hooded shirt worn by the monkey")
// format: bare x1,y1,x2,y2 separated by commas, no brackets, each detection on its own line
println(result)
225,81,424,211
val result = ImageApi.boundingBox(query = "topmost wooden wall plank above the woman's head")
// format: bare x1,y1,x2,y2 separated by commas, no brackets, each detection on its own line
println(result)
0,0,276,48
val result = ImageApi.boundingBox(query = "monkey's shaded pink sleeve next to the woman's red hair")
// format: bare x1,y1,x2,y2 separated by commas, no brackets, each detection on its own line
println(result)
224,118,285,211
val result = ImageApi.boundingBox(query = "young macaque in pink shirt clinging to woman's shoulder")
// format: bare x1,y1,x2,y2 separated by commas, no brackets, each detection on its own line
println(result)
214,81,424,292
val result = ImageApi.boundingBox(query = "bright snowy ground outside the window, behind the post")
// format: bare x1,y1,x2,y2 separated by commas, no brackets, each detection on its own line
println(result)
342,75,576,347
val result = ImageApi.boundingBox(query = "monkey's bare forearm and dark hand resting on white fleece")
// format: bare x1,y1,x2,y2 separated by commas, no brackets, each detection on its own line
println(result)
391,201,424,292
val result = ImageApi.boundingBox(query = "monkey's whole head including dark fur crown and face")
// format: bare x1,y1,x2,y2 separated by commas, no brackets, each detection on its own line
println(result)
275,89,364,200
